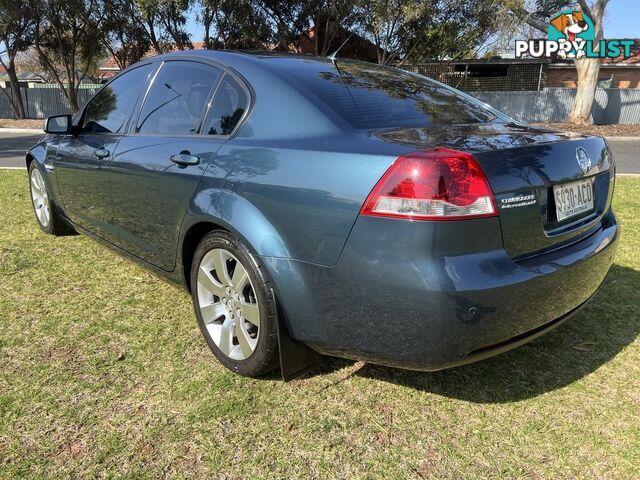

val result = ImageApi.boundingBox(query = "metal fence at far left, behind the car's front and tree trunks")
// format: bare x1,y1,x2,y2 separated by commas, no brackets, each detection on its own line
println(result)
0,85,100,118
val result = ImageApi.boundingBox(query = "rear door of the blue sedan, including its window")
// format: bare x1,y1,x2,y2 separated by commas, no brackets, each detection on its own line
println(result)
111,60,246,271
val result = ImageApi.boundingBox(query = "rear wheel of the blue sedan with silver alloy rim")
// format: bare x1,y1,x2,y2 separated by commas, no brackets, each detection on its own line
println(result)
191,230,278,377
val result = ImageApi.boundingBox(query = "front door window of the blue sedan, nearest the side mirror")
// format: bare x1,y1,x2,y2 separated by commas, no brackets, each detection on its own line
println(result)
80,64,153,133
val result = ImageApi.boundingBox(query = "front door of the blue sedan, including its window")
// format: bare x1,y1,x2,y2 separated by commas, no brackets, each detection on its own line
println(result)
55,63,153,242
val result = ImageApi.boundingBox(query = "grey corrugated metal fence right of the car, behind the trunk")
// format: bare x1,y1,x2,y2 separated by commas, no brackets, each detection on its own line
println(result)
469,88,640,125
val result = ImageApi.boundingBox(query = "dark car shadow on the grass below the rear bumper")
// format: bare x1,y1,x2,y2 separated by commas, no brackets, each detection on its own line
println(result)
344,265,640,403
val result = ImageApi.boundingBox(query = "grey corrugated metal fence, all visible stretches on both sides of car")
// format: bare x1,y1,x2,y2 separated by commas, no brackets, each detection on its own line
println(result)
0,87,640,125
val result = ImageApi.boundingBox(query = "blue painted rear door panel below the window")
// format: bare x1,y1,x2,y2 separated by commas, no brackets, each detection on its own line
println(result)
110,134,223,271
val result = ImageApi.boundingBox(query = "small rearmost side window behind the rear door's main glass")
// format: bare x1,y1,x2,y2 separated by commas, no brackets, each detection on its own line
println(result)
202,75,249,135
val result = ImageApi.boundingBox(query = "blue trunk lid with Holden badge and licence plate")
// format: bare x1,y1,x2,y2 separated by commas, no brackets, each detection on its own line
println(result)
376,123,614,258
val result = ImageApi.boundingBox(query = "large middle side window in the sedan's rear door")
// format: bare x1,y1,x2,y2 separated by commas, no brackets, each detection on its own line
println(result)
136,61,221,135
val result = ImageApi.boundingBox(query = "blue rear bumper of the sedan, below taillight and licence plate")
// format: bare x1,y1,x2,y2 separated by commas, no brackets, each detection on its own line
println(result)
267,211,618,370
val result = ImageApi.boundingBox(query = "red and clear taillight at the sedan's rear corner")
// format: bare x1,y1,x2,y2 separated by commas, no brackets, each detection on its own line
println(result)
360,148,497,220
